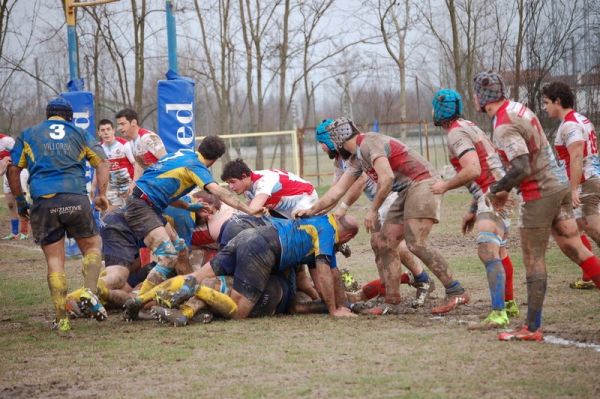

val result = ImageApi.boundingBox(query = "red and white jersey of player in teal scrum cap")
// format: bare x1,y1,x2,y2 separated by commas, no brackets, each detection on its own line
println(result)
448,119,504,193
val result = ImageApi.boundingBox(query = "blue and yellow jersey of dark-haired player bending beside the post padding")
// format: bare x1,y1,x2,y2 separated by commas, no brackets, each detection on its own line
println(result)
135,149,215,210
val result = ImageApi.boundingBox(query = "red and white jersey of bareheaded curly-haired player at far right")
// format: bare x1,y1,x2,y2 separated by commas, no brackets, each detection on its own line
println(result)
554,111,600,183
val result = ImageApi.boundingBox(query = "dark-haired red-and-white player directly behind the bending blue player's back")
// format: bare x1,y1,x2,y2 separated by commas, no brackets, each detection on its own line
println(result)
115,108,167,180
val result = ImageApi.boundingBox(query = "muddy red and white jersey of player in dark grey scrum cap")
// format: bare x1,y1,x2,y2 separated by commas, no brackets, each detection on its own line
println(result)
493,100,568,202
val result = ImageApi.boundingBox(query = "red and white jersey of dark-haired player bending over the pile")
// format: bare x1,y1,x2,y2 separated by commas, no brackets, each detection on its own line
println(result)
245,169,315,211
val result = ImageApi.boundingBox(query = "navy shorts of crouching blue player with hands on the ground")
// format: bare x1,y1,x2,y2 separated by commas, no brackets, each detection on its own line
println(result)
210,226,281,303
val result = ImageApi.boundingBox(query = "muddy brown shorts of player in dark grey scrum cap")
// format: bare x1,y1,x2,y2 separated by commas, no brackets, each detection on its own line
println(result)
519,187,574,229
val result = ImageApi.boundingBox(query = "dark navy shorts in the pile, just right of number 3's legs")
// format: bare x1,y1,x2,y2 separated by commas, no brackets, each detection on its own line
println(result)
100,210,144,272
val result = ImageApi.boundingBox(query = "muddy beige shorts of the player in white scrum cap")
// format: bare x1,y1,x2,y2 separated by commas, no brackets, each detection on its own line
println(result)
385,179,442,224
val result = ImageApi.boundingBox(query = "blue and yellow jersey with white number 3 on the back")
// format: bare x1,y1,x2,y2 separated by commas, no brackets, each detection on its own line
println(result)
10,117,106,199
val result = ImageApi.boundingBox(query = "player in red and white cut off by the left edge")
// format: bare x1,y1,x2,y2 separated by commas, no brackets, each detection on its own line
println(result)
0,133,29,240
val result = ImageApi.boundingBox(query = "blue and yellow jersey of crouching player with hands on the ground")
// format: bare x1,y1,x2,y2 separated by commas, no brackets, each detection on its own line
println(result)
271,215,339,270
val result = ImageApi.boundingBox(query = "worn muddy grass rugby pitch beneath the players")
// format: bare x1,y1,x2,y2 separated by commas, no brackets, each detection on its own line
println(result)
0,192,600,398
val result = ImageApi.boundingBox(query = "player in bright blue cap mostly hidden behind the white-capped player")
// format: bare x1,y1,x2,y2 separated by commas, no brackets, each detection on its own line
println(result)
315,119,435,314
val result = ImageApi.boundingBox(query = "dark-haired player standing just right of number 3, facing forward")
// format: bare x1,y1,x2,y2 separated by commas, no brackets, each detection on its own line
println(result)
92,119,135,210
